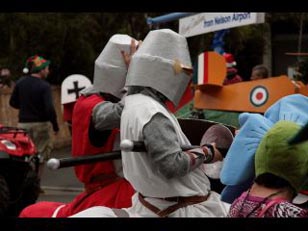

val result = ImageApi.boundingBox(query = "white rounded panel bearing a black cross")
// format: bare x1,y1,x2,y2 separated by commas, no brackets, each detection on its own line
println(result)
61,74,92,104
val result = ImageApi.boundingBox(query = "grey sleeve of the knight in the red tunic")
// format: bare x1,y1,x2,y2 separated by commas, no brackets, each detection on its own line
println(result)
92,101,124,131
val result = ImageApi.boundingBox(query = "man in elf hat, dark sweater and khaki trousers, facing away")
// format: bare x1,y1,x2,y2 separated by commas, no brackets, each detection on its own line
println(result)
9,55,59,182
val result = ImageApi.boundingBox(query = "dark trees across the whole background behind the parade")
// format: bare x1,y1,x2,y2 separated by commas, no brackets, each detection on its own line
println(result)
0,12,308,85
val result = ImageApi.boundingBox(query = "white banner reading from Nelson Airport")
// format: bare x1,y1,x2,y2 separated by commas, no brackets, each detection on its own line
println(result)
179,12,265,37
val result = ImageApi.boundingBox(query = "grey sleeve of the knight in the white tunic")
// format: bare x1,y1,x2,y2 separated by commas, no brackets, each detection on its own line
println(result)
143,113,204,179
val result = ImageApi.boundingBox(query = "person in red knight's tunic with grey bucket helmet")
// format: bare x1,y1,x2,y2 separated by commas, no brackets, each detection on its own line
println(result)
20,34,137,217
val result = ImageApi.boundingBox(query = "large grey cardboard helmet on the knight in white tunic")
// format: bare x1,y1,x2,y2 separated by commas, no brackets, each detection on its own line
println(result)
125,29,191,105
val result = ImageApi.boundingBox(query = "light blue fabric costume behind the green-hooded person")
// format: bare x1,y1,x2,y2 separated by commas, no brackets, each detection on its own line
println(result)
220,94,308,204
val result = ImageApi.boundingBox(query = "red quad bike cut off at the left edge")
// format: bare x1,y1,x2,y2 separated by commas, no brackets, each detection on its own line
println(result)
0,124,40,217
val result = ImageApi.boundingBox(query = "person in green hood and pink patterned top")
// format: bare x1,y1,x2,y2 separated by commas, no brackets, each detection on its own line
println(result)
229,121,308,217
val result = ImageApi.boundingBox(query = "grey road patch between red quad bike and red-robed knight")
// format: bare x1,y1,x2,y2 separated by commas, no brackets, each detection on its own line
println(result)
38,147,83,202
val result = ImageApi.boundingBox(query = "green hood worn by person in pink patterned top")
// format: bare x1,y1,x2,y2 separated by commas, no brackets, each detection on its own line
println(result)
255,120,308,192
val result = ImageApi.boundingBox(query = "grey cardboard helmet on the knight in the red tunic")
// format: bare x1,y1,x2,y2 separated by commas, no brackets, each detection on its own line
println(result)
93,34,137,99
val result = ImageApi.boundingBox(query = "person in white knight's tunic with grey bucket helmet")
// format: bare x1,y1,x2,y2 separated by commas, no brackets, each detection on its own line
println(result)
74,29,231,217
